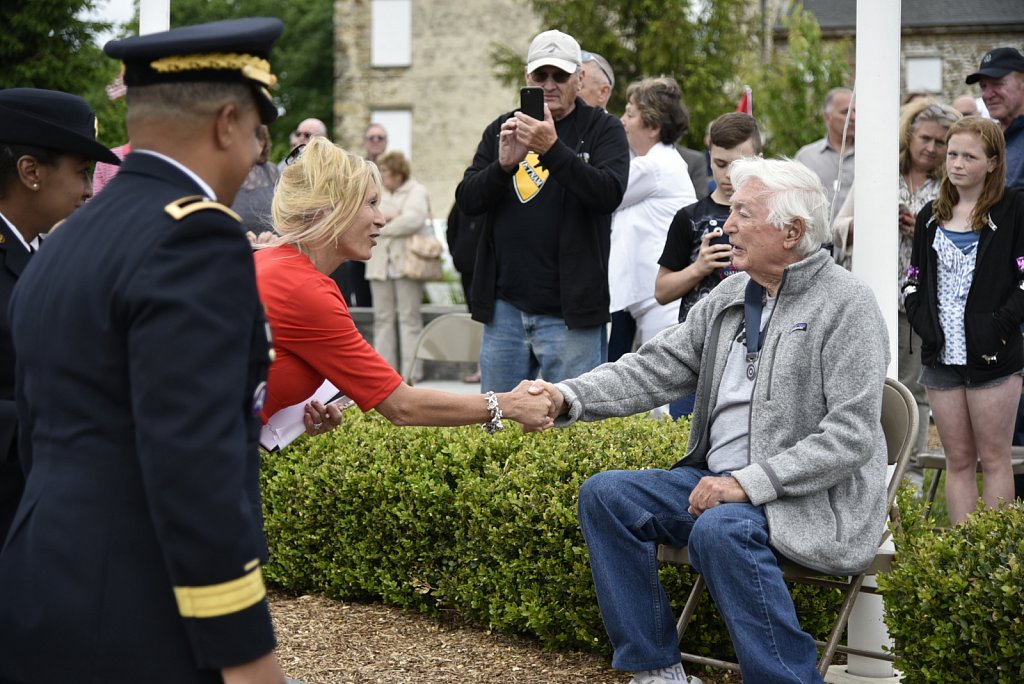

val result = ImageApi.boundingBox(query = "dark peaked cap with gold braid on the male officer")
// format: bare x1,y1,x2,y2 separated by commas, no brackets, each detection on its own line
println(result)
103,16,285,124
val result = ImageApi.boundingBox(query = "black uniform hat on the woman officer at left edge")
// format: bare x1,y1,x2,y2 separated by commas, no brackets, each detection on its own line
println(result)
0,88,121,164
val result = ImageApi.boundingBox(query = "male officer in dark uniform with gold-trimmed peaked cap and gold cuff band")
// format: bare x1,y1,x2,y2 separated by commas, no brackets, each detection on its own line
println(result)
0,18,284,684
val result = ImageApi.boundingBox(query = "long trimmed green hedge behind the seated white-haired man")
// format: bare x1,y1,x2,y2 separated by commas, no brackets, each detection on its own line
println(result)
262,412,838,657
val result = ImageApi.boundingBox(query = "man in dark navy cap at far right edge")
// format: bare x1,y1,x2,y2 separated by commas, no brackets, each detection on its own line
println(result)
967,47,1024,187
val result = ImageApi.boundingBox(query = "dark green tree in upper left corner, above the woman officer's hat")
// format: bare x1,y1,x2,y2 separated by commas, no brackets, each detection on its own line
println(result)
0,0,126,146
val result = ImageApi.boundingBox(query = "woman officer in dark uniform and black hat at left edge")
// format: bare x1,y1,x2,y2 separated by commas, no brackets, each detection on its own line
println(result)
0,88,120,546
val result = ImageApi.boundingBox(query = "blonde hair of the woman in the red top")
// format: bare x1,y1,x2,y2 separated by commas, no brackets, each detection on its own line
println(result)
270,137,381,250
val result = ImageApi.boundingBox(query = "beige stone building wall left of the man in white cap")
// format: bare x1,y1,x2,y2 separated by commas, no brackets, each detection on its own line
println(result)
334,0,541,218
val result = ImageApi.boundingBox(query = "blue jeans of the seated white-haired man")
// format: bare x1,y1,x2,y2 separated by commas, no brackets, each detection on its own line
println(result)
580,467,822,684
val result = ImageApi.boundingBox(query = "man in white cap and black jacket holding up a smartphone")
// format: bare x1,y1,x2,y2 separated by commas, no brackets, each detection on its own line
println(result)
456,31,630,392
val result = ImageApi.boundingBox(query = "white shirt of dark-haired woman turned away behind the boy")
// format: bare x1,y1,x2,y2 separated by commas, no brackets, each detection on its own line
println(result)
608,142,697,311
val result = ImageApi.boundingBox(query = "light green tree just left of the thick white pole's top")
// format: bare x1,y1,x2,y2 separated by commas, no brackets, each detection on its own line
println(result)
751,4,852,156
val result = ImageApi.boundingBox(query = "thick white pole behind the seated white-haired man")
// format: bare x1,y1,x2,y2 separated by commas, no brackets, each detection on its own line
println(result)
847,0,901,679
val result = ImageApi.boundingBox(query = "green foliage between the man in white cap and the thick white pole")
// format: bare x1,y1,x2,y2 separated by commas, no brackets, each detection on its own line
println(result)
492,0,852,156
